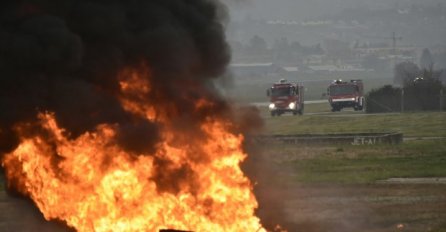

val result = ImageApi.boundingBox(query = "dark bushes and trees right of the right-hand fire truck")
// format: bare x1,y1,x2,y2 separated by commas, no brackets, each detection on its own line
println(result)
366,49,446,113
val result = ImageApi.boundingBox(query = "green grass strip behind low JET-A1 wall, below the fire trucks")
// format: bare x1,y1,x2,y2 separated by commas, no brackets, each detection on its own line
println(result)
262,107,446,137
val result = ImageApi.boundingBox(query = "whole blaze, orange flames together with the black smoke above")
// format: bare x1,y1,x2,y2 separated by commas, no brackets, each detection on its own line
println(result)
0,0,264,231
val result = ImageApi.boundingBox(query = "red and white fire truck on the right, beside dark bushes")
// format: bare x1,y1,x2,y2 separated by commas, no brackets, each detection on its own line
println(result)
327,80,364,112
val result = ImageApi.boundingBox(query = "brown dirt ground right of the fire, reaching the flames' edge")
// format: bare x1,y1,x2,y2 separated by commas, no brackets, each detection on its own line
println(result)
248,149,446,232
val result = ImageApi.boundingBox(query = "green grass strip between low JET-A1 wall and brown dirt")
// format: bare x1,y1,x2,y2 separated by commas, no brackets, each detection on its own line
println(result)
284,140,446,184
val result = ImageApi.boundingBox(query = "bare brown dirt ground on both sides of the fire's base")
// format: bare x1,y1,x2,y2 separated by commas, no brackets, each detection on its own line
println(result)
0,165,446,232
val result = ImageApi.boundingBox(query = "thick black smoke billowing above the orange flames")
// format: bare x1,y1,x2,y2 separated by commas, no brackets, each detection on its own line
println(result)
0,0,230,153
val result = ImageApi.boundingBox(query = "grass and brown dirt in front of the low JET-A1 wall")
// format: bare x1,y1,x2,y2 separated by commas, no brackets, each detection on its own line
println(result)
260,140,446,232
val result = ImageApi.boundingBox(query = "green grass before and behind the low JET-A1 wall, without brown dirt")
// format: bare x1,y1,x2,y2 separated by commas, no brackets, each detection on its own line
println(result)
262,104,446,183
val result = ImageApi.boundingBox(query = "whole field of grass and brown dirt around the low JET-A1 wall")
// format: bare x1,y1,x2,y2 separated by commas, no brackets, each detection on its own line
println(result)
251,103,446,232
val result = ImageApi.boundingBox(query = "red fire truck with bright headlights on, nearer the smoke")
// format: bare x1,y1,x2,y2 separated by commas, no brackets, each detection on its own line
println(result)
267,79,304,116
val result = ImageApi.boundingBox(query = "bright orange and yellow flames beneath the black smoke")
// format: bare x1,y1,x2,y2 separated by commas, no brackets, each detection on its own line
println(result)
2,66,265,232
